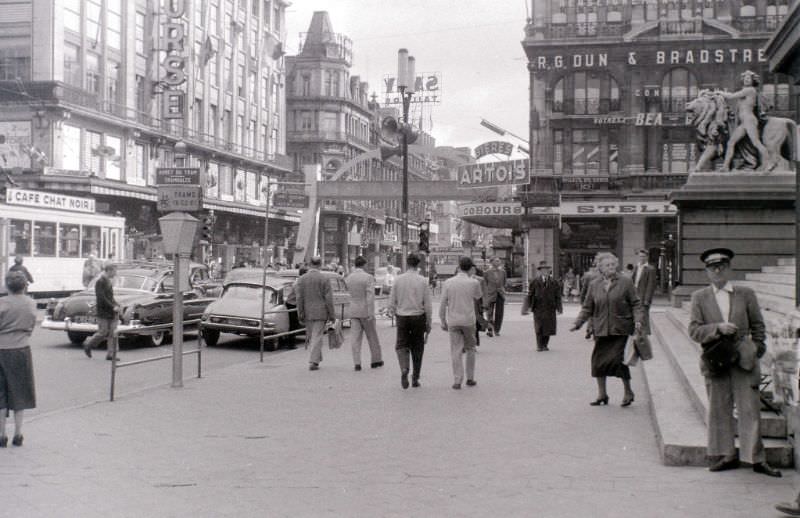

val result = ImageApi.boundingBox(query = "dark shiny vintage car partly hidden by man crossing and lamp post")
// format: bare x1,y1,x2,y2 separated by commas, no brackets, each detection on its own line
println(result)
42,262,221,346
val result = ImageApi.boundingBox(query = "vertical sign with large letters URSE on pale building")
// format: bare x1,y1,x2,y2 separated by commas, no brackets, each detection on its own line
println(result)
161,0,186,119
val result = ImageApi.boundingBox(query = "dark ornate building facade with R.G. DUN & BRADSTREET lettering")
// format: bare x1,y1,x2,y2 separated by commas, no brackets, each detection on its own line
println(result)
523,0,798,280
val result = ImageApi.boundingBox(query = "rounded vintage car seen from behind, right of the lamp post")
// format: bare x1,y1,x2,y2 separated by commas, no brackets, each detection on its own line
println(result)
200,268,349,350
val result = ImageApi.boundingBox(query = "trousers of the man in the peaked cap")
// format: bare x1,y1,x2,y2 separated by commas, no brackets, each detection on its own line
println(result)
706,366,765,464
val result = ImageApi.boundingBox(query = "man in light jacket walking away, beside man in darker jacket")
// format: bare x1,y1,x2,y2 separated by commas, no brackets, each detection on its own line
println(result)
344,256,383,371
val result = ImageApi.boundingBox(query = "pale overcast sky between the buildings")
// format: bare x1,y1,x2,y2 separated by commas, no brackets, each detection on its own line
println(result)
286,0,529,154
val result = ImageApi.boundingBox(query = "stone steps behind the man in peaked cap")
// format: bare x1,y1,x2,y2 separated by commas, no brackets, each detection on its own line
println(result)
642,259,800,467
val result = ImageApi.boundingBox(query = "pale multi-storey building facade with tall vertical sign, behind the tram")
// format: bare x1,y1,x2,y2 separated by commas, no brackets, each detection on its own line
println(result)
0,0,299,268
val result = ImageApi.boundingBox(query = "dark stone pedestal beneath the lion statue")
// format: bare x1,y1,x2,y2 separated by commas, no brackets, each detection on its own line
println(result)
670,171,795,305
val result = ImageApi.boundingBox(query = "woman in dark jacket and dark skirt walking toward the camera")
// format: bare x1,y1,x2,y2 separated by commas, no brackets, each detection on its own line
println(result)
570,253,644,406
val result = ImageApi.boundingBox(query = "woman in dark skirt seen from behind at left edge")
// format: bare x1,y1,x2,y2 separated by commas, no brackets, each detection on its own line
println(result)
0,272,36,448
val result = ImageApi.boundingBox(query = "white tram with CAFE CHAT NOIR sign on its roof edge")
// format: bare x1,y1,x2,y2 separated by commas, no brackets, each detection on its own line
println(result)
0,188,125,298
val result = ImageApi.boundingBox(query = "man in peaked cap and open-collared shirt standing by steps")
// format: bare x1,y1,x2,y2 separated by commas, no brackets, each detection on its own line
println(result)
689,248,781,477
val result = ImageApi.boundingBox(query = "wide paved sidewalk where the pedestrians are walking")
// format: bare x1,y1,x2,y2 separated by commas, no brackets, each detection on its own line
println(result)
0,306,800,518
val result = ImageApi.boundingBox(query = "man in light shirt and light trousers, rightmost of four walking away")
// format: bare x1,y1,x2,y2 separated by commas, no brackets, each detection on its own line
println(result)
439,257,483,390
